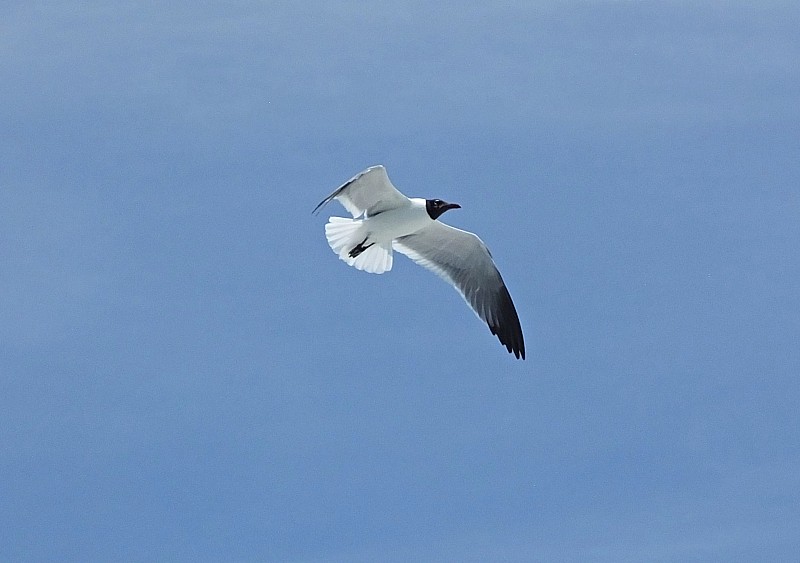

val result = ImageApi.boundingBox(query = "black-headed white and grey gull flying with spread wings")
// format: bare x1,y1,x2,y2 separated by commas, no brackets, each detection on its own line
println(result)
312,165,525,360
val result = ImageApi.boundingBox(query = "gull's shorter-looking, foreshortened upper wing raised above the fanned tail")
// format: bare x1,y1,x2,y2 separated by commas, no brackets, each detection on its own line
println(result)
312,165,409,217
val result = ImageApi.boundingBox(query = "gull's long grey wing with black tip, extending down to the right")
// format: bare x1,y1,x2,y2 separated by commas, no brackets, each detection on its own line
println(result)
394,221,525,360
